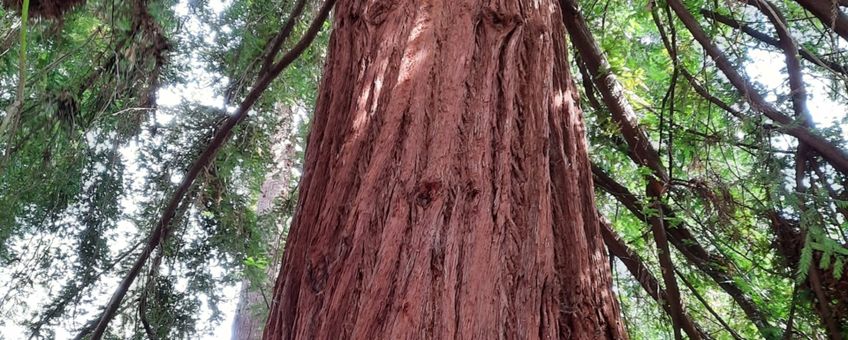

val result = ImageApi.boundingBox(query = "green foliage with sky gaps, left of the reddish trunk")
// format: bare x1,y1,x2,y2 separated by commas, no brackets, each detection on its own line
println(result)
0,0,328,339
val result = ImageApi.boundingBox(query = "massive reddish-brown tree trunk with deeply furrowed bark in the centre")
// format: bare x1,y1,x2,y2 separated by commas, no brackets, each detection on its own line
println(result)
264,0,626,339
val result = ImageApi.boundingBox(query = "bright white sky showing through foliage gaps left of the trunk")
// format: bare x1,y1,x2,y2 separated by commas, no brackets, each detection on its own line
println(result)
0,0,239,340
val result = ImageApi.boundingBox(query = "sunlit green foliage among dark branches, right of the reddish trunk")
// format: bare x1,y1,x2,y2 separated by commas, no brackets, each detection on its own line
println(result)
588,0,848,339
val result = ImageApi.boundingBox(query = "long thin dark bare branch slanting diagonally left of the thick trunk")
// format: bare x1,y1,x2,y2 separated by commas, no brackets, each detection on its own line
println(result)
81,0,335,340
